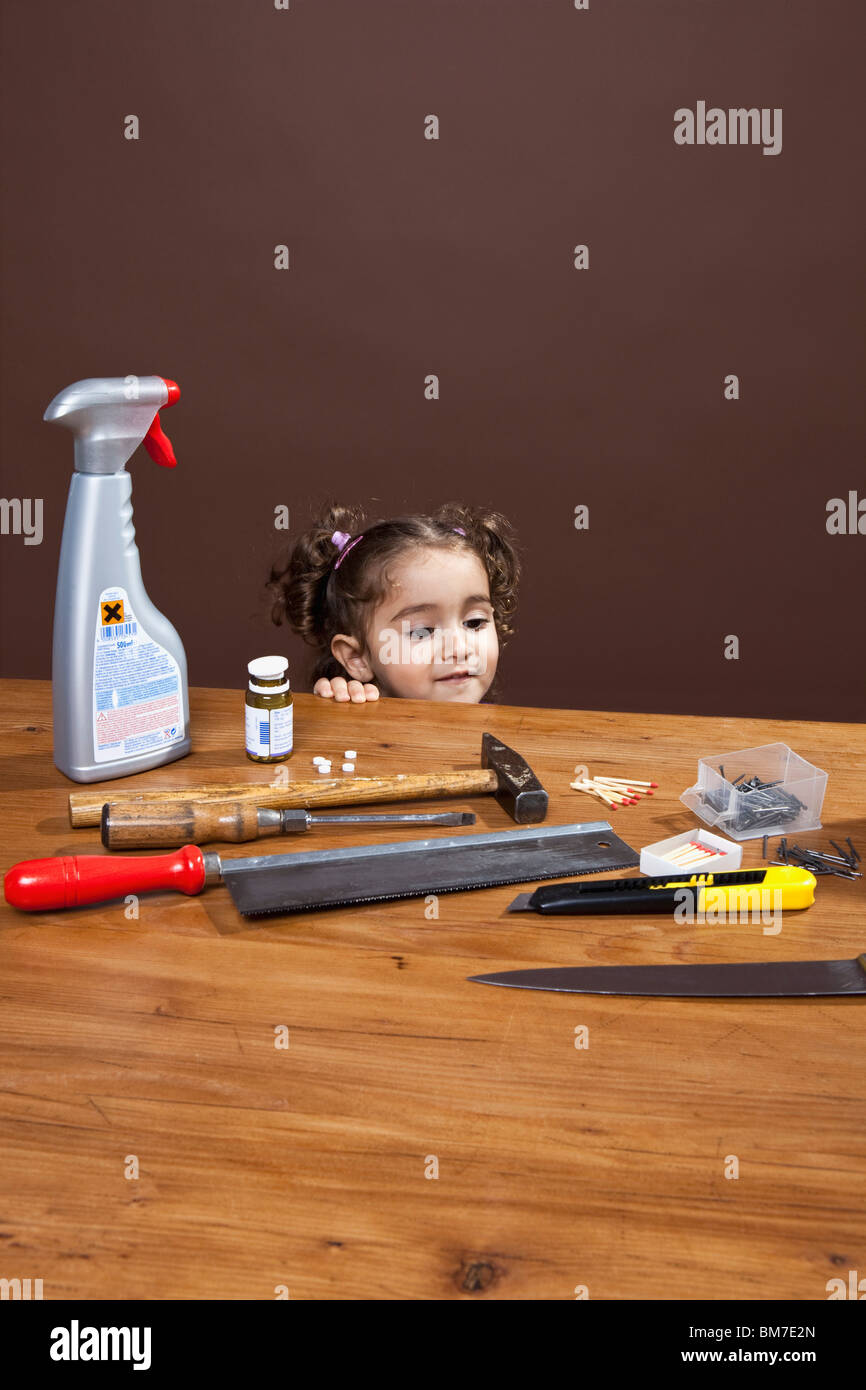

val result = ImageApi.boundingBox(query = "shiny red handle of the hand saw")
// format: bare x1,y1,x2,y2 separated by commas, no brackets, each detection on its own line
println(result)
3,845,204,912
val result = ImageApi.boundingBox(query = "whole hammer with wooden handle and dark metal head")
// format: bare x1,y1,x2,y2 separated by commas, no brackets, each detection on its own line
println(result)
70,734,548,845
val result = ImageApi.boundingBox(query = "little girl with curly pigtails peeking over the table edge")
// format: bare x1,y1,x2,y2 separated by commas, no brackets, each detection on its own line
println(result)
268,505,520,703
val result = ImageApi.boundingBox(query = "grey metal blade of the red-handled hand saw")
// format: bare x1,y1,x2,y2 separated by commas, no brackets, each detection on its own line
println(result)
221,820,639,917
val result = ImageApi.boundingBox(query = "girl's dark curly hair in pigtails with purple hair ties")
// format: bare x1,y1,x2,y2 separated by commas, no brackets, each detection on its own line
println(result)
267,502,520,681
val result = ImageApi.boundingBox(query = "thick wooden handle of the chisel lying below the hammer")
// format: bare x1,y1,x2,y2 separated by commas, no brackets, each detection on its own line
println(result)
101,801,260,849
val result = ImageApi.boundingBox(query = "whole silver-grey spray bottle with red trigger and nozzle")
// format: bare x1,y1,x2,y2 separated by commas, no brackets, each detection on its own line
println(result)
44,377,189,783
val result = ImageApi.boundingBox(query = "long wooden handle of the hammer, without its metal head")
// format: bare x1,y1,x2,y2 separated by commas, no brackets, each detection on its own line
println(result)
70,767,499,826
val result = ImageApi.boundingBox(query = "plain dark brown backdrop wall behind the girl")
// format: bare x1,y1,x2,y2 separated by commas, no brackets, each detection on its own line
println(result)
0,0,866,719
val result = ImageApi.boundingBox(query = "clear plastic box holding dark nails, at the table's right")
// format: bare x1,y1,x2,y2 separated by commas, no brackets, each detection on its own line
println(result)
680,744,827,840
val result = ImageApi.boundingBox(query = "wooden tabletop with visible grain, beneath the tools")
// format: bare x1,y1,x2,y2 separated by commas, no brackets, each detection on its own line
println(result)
0,681,866,1300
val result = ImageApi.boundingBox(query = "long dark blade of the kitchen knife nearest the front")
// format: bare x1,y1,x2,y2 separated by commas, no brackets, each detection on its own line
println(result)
468,952,866,999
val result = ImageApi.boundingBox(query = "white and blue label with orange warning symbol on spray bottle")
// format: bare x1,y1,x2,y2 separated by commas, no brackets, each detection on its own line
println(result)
93,588,183,763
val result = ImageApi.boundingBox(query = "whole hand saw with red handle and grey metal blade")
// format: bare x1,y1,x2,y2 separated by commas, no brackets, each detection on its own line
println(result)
4,820,639,916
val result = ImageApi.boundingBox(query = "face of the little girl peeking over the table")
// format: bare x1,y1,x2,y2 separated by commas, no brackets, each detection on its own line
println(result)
366,548,499,705
